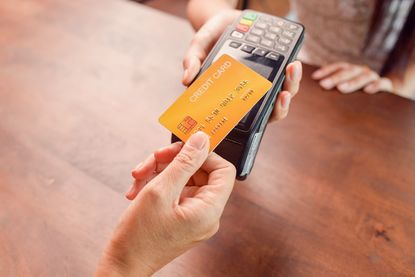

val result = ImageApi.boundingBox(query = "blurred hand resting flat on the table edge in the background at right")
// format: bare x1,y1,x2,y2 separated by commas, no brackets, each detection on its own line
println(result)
311,62,394,94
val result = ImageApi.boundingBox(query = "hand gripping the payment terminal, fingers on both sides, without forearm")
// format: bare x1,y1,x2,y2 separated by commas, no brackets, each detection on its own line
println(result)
182,9,302,122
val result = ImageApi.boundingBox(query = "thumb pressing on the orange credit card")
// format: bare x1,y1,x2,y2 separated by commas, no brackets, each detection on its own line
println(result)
156,132,209,199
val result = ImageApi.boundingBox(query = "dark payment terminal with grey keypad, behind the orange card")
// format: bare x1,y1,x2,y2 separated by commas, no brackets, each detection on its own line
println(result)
172,10,304,180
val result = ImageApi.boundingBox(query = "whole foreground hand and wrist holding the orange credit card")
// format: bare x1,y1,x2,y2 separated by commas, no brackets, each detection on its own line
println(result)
96,132,236,276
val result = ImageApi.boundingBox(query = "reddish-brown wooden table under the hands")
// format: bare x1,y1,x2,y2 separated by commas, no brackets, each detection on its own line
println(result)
0,0,415,276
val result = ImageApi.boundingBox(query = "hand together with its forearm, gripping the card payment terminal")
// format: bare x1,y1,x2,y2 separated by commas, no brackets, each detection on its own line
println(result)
182,0,302,122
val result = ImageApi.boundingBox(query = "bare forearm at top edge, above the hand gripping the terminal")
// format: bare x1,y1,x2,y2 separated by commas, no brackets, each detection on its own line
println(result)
187,0,237,30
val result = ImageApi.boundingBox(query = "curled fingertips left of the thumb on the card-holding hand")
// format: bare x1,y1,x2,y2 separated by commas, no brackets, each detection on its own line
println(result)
125,142,183,200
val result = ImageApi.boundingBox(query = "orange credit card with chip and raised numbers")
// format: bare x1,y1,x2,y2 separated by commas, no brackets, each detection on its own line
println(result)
159,55,272,151
